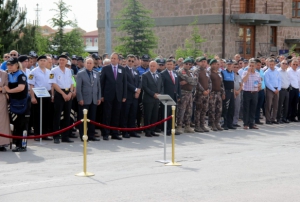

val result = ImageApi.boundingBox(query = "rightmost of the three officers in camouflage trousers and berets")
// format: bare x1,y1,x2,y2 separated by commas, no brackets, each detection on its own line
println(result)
208,59,225,131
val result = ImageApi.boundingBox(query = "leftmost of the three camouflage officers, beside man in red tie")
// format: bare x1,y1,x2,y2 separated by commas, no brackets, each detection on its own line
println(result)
176,58,197,134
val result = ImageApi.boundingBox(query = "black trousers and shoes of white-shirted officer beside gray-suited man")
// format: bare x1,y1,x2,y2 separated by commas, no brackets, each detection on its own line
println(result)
53,91,72,139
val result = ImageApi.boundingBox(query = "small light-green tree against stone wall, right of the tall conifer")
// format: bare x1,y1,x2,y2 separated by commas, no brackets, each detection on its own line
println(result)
176,20,206,58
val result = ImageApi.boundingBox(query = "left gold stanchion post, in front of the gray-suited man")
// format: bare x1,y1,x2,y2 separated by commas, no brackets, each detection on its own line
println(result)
76,109,94,177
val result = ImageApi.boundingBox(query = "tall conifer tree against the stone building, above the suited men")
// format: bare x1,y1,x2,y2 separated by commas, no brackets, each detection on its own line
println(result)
115,0,157,55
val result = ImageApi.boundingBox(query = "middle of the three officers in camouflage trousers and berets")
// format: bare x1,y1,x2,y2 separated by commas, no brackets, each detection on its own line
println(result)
194,57,211,133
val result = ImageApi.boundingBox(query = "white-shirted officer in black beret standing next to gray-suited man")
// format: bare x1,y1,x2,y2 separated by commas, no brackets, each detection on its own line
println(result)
49,55,74,144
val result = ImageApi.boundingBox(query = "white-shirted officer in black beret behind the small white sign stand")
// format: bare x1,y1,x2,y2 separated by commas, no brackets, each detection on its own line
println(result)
28,55,53,140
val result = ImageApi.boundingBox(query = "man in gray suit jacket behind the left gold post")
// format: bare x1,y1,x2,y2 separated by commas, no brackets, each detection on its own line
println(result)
76,58,101,141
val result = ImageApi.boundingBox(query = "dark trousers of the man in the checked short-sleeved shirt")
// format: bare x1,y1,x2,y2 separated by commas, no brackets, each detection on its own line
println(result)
243,91,258,127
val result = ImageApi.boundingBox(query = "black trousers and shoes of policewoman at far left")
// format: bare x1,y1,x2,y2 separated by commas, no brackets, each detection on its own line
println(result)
10,114,29,147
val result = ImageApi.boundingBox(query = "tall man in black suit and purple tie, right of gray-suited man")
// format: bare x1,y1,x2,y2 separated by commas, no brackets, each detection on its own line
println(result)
100,53,127,140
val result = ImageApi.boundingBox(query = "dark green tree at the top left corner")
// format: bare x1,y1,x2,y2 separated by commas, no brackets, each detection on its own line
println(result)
0,0,26,55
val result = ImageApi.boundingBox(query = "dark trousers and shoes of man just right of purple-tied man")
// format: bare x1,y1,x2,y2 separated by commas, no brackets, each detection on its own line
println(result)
120,99,138,134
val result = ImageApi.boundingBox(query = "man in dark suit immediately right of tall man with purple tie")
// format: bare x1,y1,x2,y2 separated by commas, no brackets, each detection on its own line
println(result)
120,55,141,138
